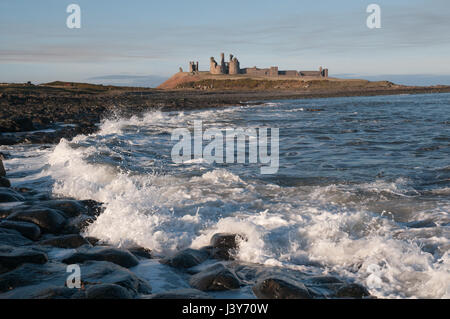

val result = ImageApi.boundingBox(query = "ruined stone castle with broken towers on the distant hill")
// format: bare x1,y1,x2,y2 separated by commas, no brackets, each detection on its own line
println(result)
185,53,328,78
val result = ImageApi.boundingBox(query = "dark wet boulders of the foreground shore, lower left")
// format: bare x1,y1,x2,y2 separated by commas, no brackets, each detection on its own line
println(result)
0,160,370,299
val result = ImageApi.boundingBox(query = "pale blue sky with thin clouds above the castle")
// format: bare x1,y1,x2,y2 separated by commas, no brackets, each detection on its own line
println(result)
0,0,450,86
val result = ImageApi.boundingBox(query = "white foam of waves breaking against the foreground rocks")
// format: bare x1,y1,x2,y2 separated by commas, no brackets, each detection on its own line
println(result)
4,110,450,298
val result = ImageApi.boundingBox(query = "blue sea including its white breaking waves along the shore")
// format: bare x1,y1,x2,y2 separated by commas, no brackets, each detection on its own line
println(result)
1,94,450,298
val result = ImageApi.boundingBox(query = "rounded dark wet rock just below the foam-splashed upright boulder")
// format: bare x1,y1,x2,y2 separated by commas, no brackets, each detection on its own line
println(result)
189,264,240,291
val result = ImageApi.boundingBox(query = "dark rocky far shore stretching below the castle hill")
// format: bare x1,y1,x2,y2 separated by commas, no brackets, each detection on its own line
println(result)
0,82,450,145
